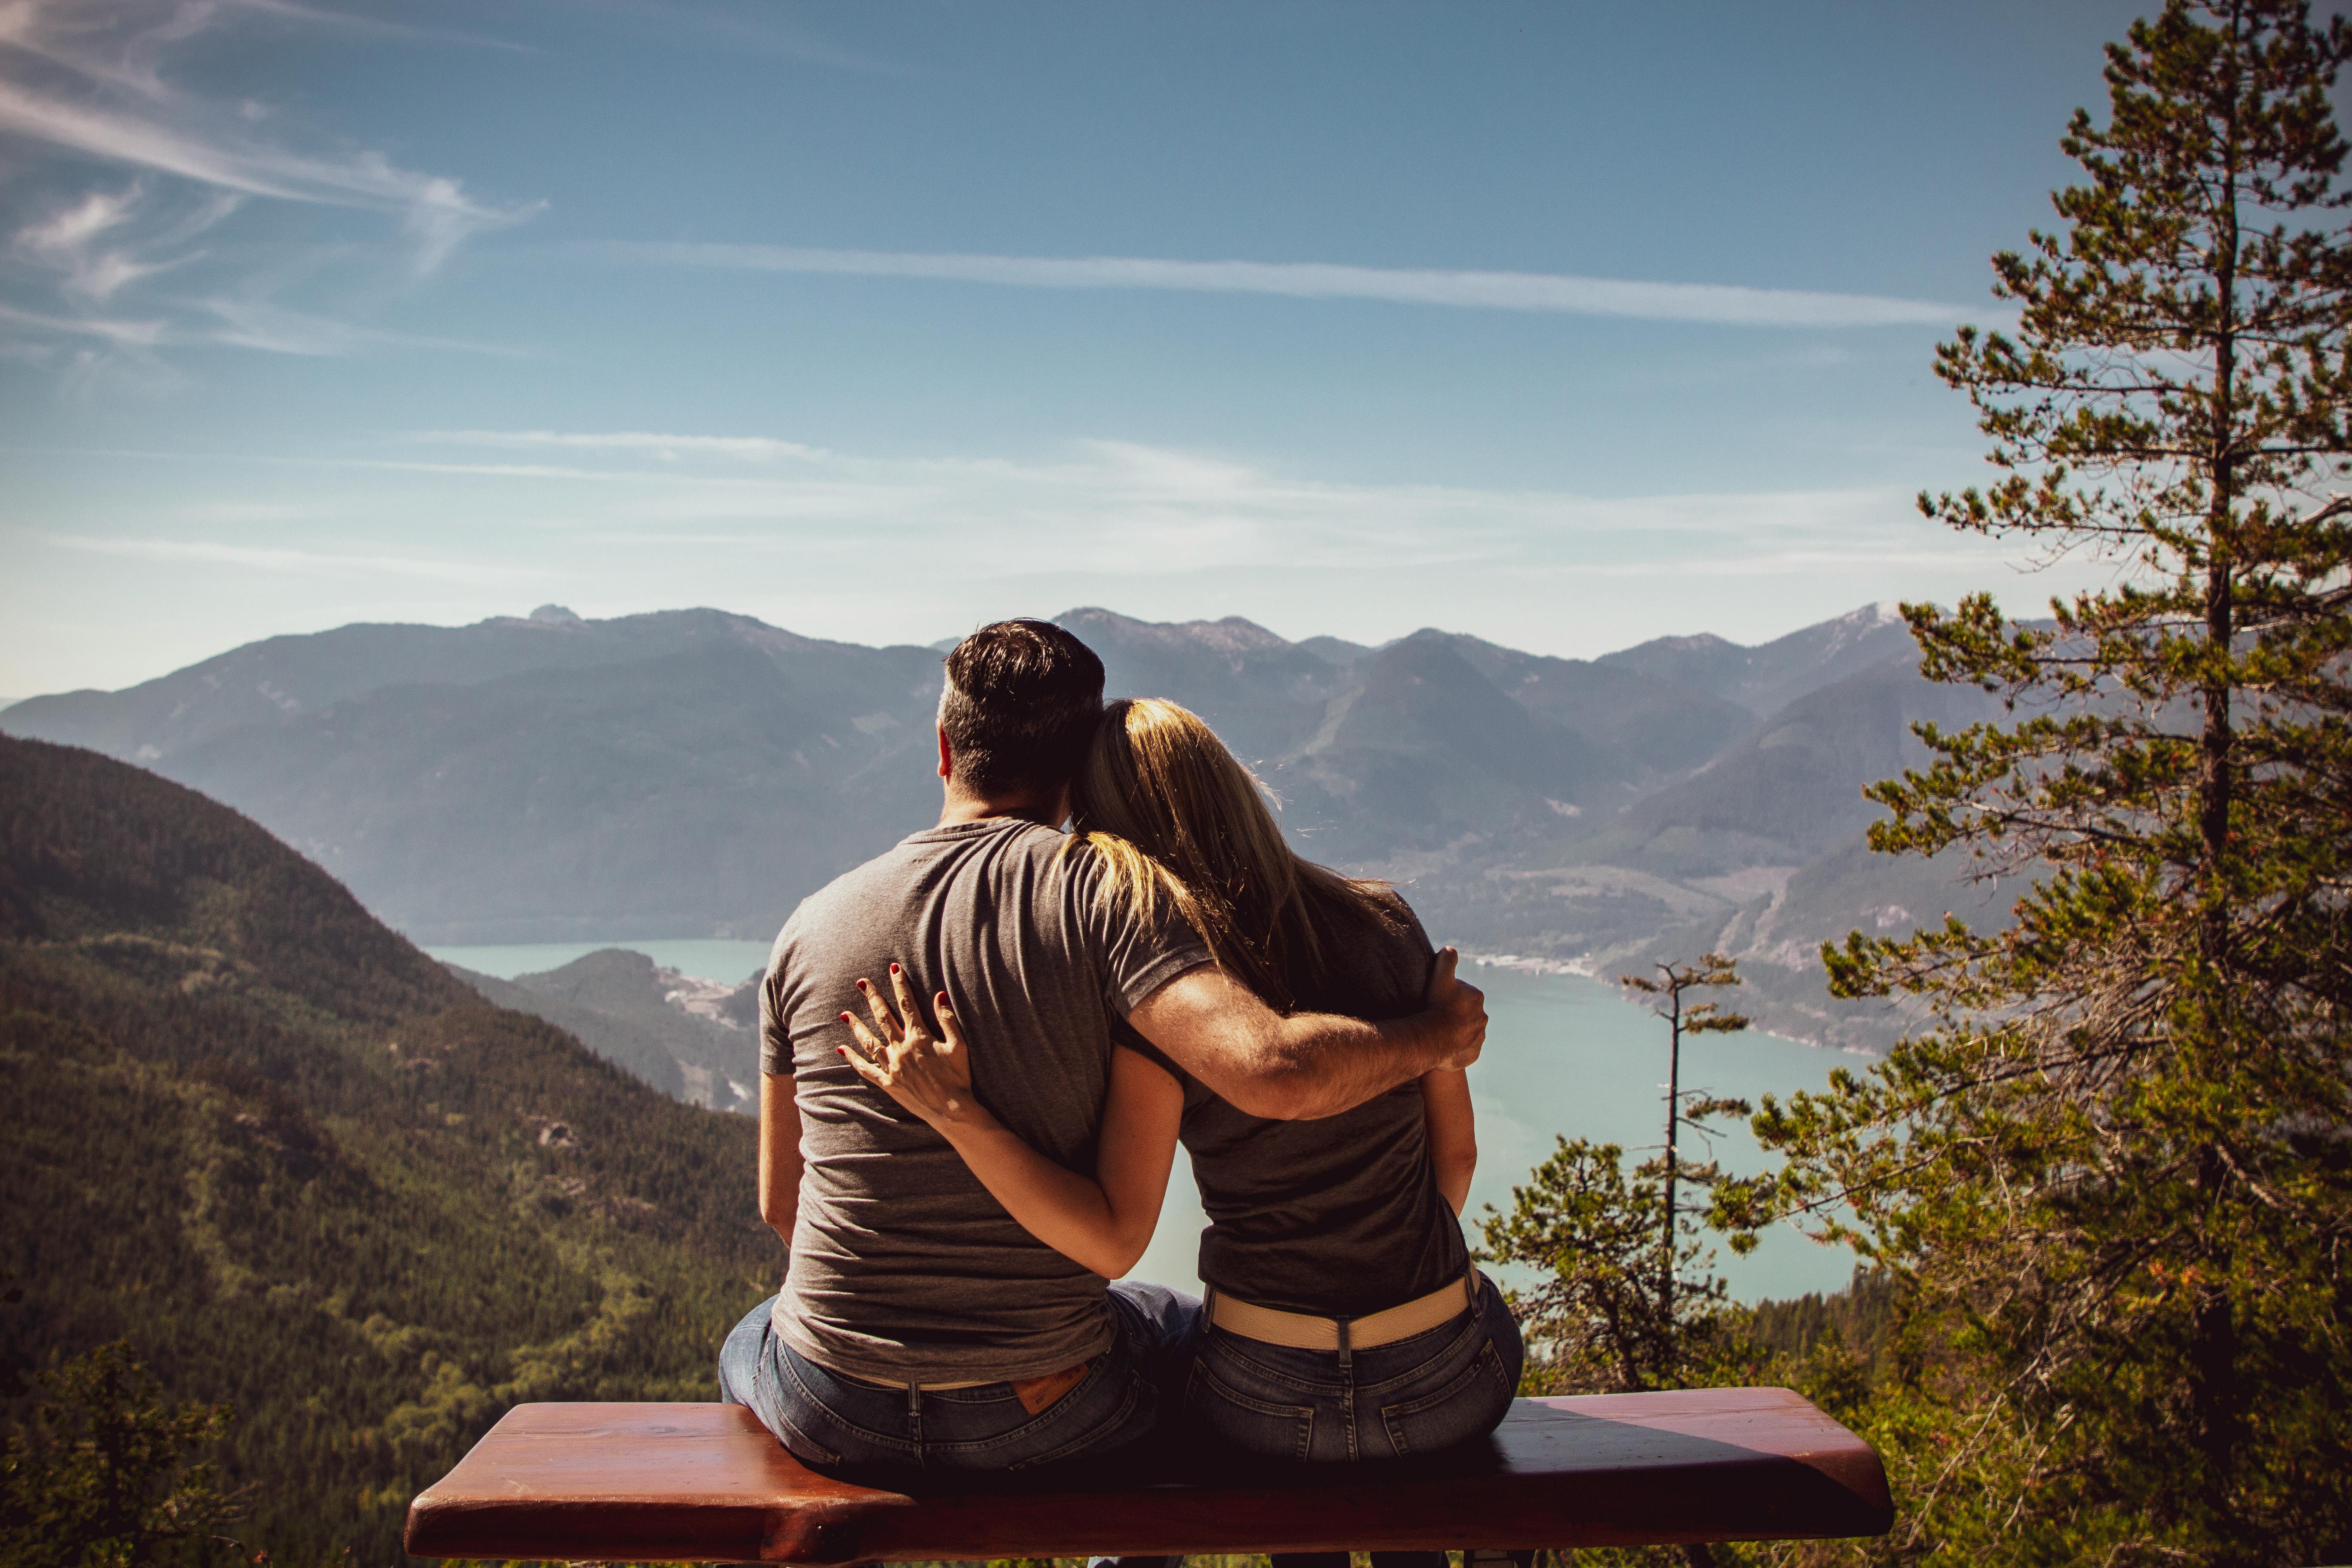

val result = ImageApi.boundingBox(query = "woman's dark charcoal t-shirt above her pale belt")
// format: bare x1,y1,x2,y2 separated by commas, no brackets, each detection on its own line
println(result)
1120,898,1470,1317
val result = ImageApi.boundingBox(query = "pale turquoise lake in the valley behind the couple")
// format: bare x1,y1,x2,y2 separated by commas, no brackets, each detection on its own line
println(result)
426,938,1868,1300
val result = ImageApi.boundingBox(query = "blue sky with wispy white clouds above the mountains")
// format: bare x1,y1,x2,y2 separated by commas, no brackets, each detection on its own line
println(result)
0,0,2173,698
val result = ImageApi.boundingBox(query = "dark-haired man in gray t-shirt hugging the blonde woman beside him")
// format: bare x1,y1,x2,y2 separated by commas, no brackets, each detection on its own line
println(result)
720,621,1486,1469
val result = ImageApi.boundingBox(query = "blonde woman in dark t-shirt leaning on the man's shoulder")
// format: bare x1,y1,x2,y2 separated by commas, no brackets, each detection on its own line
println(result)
844,698,1522,1523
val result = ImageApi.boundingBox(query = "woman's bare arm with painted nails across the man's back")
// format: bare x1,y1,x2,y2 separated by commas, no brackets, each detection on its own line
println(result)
840,964,1183,1279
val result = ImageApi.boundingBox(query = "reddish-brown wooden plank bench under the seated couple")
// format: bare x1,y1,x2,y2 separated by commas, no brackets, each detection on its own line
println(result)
407,1389,1893,1568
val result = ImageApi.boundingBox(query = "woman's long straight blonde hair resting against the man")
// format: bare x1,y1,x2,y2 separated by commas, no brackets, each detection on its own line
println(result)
1070,696,1402,1011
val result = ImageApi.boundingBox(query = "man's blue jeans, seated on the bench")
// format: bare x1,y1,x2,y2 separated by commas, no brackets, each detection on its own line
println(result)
720,1281,1200,1469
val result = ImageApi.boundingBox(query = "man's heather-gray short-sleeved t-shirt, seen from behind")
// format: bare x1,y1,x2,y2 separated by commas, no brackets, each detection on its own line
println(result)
760,818,1209,1382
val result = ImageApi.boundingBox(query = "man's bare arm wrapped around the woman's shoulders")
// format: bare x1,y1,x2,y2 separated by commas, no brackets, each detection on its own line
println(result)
1127,947,1486,1121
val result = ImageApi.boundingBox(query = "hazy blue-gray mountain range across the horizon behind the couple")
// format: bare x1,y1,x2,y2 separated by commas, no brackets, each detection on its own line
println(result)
0,606,2022,1053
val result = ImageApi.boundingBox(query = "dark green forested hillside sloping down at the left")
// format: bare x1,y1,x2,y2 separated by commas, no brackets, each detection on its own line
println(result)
0,741,781,1561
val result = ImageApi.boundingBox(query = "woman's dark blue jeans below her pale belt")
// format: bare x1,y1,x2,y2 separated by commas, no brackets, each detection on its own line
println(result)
1185,1277,1526,1462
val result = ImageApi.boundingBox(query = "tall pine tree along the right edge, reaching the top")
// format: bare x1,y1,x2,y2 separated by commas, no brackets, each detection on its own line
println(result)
1726,0,2352,1563
